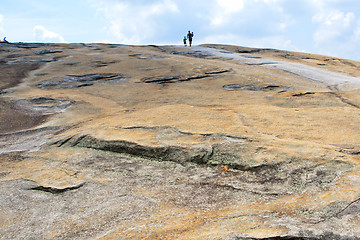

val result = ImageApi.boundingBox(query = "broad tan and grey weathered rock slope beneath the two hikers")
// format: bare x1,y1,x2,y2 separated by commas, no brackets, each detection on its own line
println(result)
0,44,360,239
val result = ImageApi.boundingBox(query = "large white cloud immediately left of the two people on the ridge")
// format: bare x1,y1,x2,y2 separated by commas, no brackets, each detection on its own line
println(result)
92,0,179,44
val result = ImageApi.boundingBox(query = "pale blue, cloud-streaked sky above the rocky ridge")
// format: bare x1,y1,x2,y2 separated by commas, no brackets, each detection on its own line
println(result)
0,0,360,61
